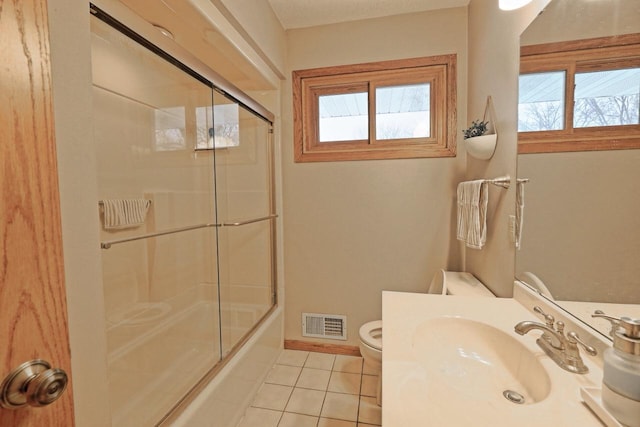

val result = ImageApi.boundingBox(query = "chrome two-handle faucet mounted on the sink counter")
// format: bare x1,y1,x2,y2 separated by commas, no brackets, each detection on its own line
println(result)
514,307,598,374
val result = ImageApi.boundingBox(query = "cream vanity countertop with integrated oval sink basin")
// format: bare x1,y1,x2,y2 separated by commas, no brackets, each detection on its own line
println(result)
382,292,602,427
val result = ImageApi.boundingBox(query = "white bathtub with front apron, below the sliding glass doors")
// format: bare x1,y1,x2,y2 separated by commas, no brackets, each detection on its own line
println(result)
108,285,283,427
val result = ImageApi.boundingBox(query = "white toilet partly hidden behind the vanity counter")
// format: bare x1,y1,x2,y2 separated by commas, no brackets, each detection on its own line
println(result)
359,270,495,405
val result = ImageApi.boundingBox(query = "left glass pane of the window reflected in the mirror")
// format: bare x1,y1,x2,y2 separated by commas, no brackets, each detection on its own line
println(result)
518,71,565,132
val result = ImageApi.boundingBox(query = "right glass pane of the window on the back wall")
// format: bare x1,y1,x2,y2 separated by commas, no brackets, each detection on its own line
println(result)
376,83,431,140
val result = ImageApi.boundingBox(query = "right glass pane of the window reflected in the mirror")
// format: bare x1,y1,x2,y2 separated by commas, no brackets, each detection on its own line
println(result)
573,68,640,128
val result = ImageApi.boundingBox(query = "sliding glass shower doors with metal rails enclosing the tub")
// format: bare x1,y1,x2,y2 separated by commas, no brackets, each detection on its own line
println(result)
91,5,276,427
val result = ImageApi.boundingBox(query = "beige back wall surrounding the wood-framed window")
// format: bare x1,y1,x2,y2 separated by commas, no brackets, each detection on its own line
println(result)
282,8,467,345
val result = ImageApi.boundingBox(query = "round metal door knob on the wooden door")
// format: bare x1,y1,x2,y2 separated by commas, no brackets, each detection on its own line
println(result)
0,359,68,409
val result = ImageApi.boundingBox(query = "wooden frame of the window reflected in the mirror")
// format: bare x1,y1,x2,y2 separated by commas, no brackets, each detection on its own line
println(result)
518,34,640,154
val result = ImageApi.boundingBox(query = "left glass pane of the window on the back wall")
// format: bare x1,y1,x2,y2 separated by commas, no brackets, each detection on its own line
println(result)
318,92,369,142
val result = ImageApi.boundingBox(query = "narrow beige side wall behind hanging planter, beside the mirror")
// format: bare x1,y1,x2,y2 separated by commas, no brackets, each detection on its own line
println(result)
466,0,549,297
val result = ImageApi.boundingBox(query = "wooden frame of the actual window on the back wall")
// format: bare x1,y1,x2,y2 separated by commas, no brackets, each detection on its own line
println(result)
292,55,457,162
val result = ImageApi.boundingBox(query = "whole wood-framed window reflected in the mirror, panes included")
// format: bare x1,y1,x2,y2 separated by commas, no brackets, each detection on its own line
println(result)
518,34,640,153
